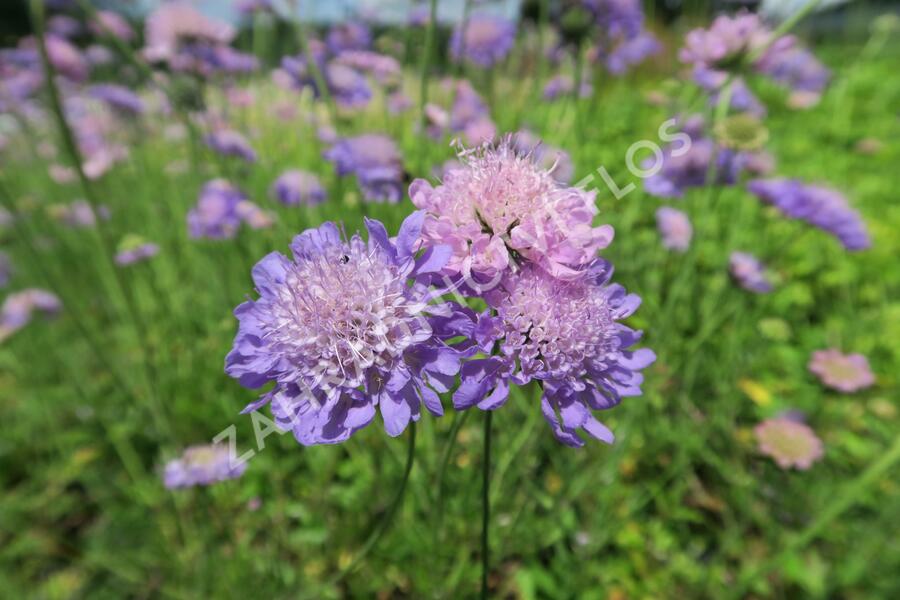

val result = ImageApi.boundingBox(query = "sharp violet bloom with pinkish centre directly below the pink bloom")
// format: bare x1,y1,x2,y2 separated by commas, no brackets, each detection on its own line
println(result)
453,259,656,447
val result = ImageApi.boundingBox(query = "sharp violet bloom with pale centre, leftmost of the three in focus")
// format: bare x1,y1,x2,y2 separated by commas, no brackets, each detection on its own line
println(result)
225,212,471,445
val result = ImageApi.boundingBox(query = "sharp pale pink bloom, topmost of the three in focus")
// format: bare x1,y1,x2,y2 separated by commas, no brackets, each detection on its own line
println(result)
409,138,613,279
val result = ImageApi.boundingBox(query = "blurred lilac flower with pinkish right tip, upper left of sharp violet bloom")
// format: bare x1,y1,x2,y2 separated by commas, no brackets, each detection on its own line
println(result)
187,179,272,239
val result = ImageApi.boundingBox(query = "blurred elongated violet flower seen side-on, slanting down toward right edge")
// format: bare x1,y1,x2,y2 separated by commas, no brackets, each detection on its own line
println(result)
747,179,872,251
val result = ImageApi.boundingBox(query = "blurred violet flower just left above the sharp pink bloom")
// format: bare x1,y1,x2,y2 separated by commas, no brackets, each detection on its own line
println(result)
324,133,404,203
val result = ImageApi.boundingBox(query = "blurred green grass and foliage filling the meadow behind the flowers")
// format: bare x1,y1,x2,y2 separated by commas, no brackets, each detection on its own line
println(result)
0,24,900,599
